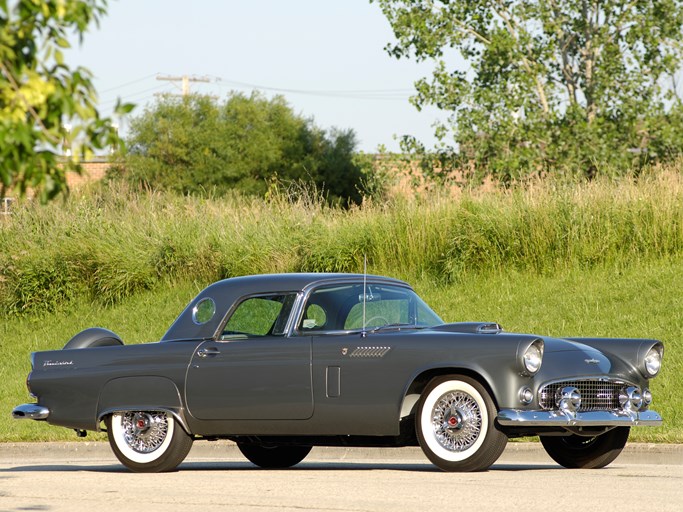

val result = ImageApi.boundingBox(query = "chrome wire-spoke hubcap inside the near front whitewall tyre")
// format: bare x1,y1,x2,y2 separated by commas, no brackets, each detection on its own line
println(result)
432,391,482,452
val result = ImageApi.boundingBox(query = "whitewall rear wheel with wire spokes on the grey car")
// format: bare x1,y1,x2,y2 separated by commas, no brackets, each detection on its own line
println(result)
105,411,192,473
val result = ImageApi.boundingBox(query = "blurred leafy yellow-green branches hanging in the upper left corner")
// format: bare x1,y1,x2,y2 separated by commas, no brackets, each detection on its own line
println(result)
0,0,132,201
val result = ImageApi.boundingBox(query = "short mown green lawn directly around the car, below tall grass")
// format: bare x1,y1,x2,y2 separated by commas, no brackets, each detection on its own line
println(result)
0,260,683,443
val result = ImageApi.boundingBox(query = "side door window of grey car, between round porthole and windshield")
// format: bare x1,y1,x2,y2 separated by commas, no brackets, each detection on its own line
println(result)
221,293,296,340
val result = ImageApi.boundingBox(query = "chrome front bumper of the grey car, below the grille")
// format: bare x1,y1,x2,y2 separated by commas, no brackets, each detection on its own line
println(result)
497,409,662,427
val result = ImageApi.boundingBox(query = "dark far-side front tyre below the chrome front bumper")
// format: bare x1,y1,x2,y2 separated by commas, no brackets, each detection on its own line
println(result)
541,427,631,469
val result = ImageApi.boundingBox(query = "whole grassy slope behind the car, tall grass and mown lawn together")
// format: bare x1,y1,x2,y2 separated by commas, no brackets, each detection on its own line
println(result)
0,170,683,442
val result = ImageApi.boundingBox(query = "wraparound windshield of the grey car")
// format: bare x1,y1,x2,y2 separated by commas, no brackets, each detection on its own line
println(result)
298,284,443,331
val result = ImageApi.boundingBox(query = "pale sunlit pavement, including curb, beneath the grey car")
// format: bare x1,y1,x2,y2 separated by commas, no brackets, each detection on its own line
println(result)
0,442,683,512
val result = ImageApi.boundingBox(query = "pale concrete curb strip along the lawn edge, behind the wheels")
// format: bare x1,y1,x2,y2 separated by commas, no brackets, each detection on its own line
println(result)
0,441,683,465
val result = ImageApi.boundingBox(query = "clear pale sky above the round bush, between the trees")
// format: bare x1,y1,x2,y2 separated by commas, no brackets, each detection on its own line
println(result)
67,0,445,152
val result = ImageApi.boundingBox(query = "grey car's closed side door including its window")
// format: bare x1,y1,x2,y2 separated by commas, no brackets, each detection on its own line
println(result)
185,294,313,420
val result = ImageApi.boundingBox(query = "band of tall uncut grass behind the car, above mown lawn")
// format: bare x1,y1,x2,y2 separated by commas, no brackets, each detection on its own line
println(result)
5,170,683,315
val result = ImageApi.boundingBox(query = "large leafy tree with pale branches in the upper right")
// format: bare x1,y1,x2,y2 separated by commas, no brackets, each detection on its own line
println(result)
371,0,683,179
